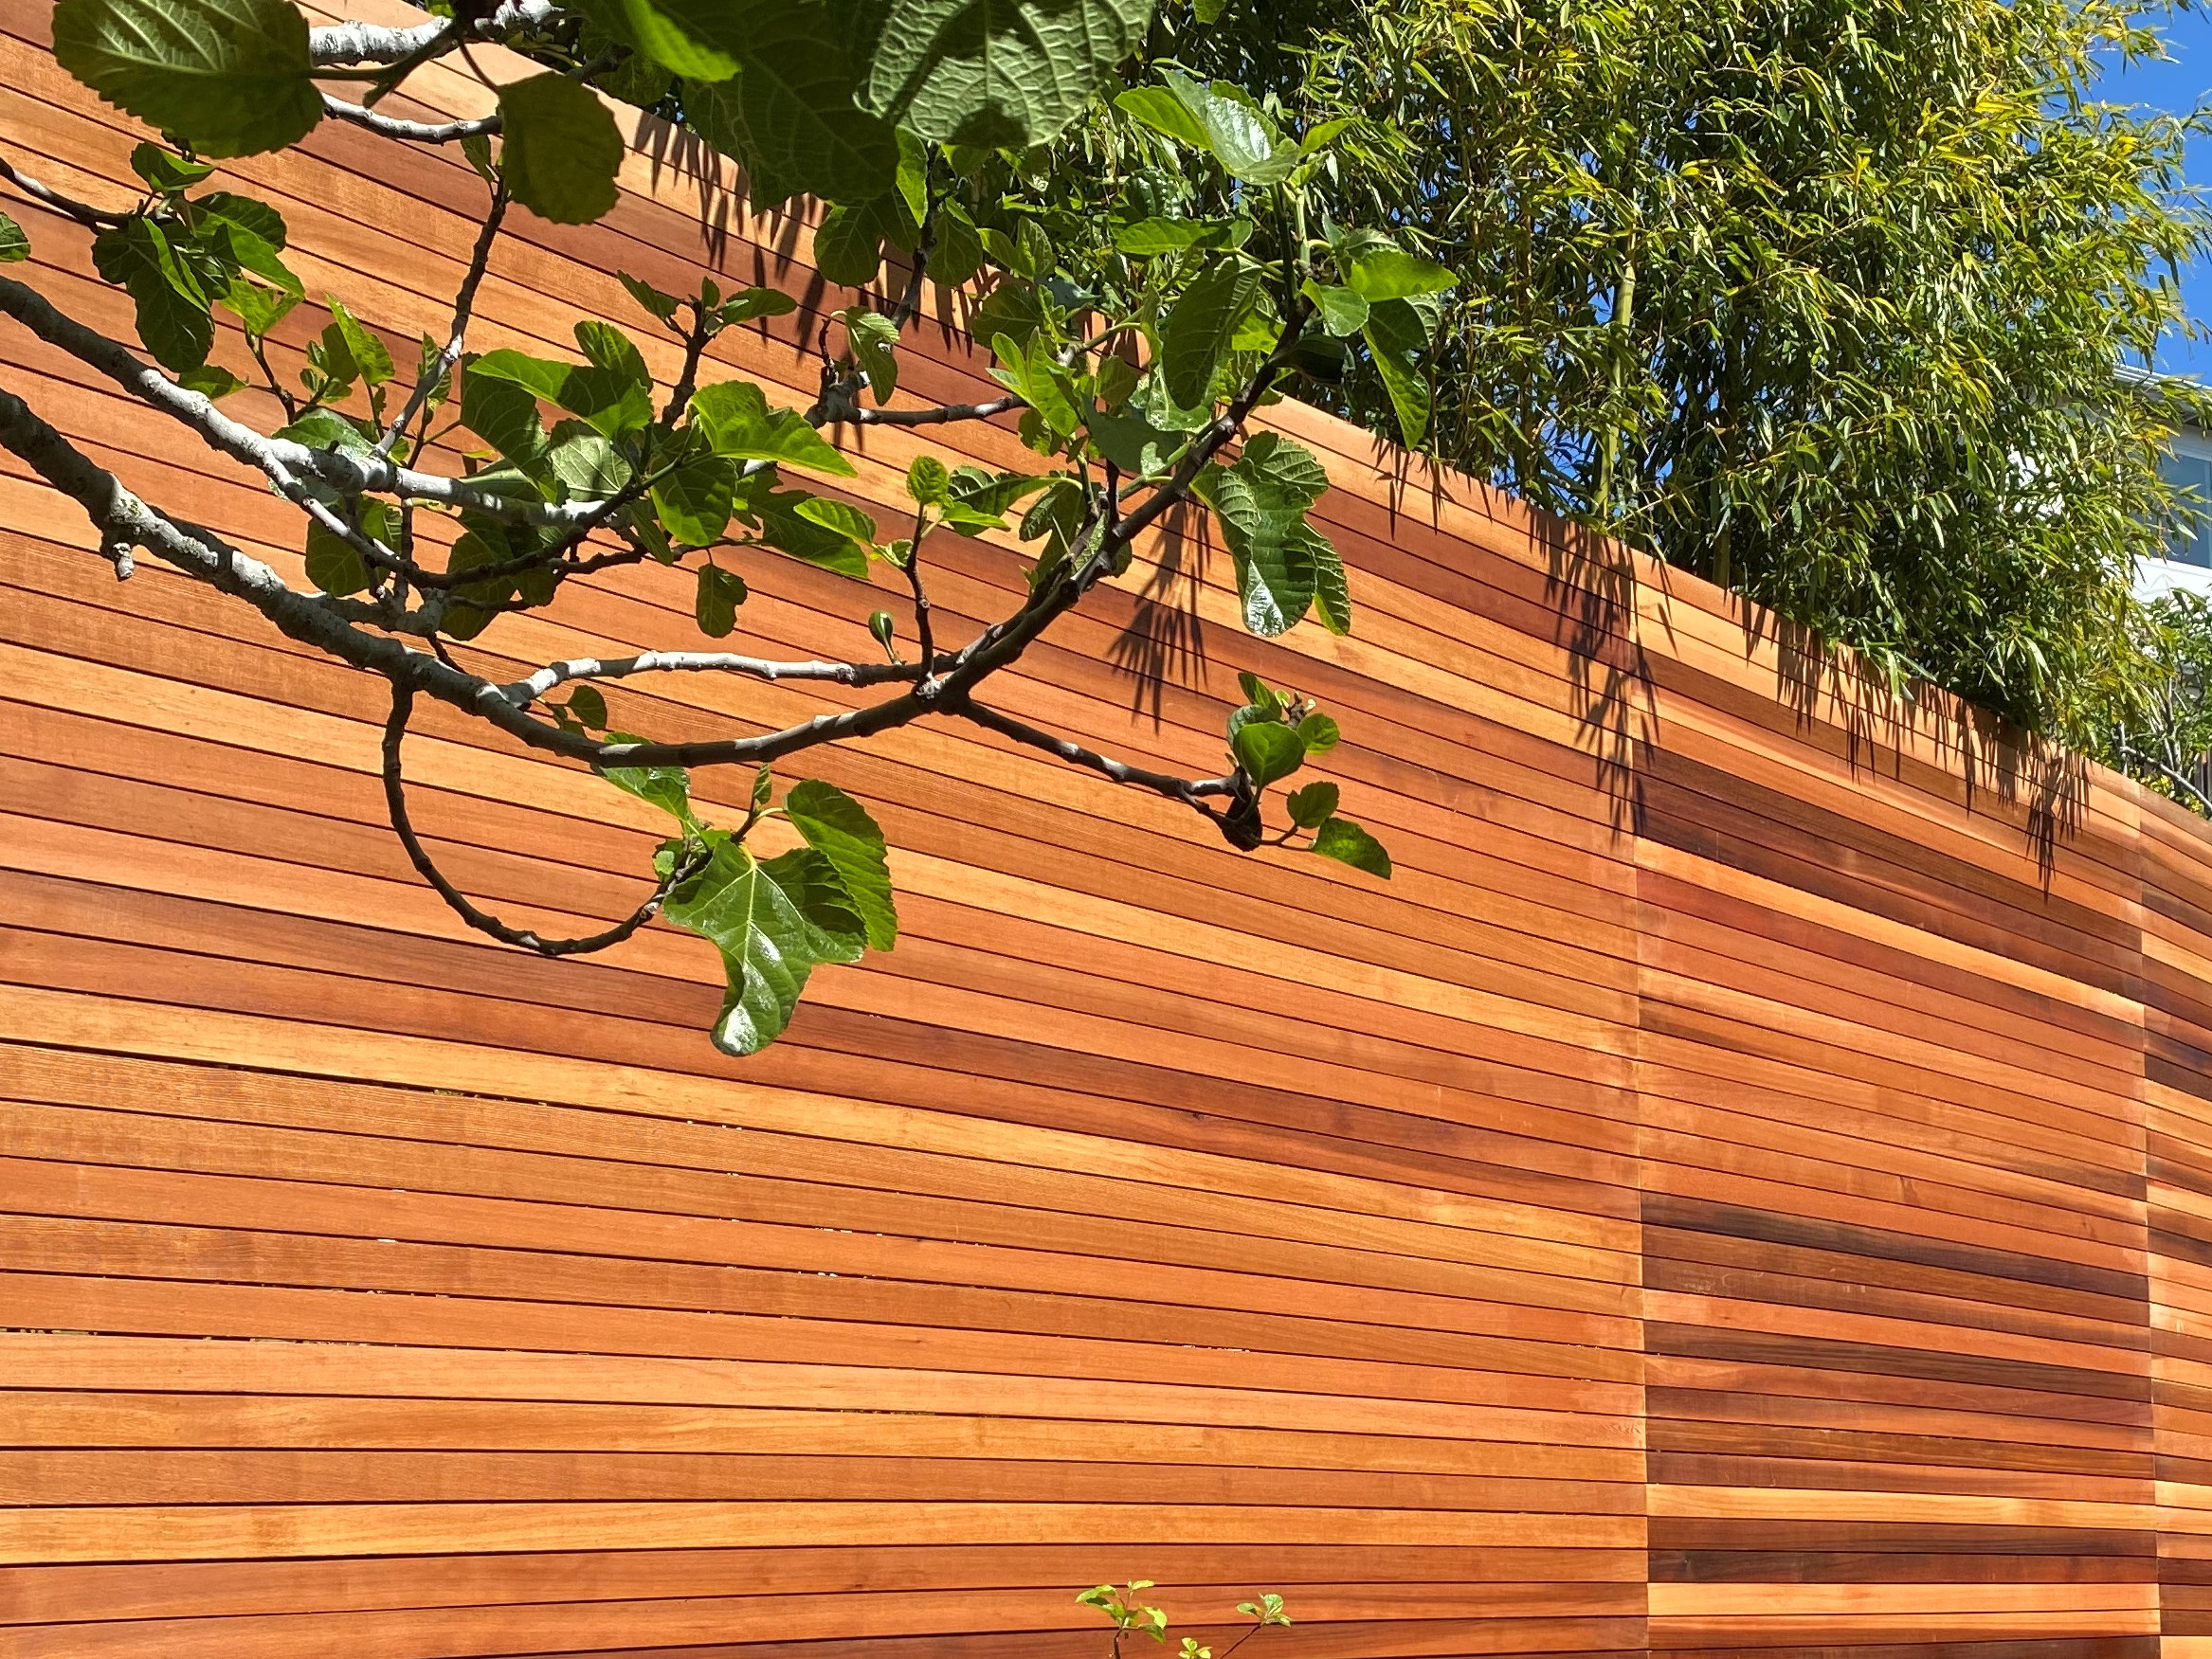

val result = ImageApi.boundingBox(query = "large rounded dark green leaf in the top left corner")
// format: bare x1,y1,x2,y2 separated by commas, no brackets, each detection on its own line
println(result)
53,0,323,157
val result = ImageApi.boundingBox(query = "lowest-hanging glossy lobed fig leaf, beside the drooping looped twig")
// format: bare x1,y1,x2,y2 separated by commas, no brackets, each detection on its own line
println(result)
662,830,867,1055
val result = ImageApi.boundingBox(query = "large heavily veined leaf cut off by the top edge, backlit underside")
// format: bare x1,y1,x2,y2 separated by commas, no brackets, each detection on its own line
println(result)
862,0,1152,148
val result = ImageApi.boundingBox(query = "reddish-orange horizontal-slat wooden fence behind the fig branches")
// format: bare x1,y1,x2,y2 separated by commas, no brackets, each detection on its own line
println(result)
0,0,2212,1659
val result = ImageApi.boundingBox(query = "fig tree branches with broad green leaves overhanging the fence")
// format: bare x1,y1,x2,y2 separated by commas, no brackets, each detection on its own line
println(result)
0,0,1415,1053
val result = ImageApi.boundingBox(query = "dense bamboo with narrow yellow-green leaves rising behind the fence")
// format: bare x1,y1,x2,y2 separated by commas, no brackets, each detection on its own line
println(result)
1192,0,2207,752
